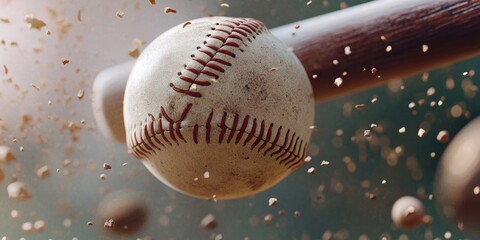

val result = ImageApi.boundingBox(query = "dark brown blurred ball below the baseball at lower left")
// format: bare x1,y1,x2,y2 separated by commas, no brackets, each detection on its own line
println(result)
96,190,148,235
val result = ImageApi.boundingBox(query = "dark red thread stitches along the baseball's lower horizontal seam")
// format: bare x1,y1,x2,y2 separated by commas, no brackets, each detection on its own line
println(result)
129,110,307,169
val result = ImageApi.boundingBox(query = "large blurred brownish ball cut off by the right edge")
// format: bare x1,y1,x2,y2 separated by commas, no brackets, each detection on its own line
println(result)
435,118,480,231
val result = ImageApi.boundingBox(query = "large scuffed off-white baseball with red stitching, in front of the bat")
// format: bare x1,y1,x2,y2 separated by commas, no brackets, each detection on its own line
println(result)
124,17,314,199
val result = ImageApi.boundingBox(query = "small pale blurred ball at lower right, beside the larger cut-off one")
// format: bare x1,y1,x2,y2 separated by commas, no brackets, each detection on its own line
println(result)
392,196,425,229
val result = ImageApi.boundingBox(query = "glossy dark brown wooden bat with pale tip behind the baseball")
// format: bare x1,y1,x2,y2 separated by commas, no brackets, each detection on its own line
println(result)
93,0,480,142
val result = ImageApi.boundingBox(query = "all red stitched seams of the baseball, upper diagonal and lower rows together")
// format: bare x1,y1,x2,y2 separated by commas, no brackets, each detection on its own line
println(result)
127,18,308,169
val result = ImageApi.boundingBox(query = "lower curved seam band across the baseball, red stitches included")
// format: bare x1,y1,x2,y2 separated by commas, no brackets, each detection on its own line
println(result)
129,112,307,171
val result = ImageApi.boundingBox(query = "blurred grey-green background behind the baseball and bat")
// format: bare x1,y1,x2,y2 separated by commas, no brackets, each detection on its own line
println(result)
0,0,480,240
